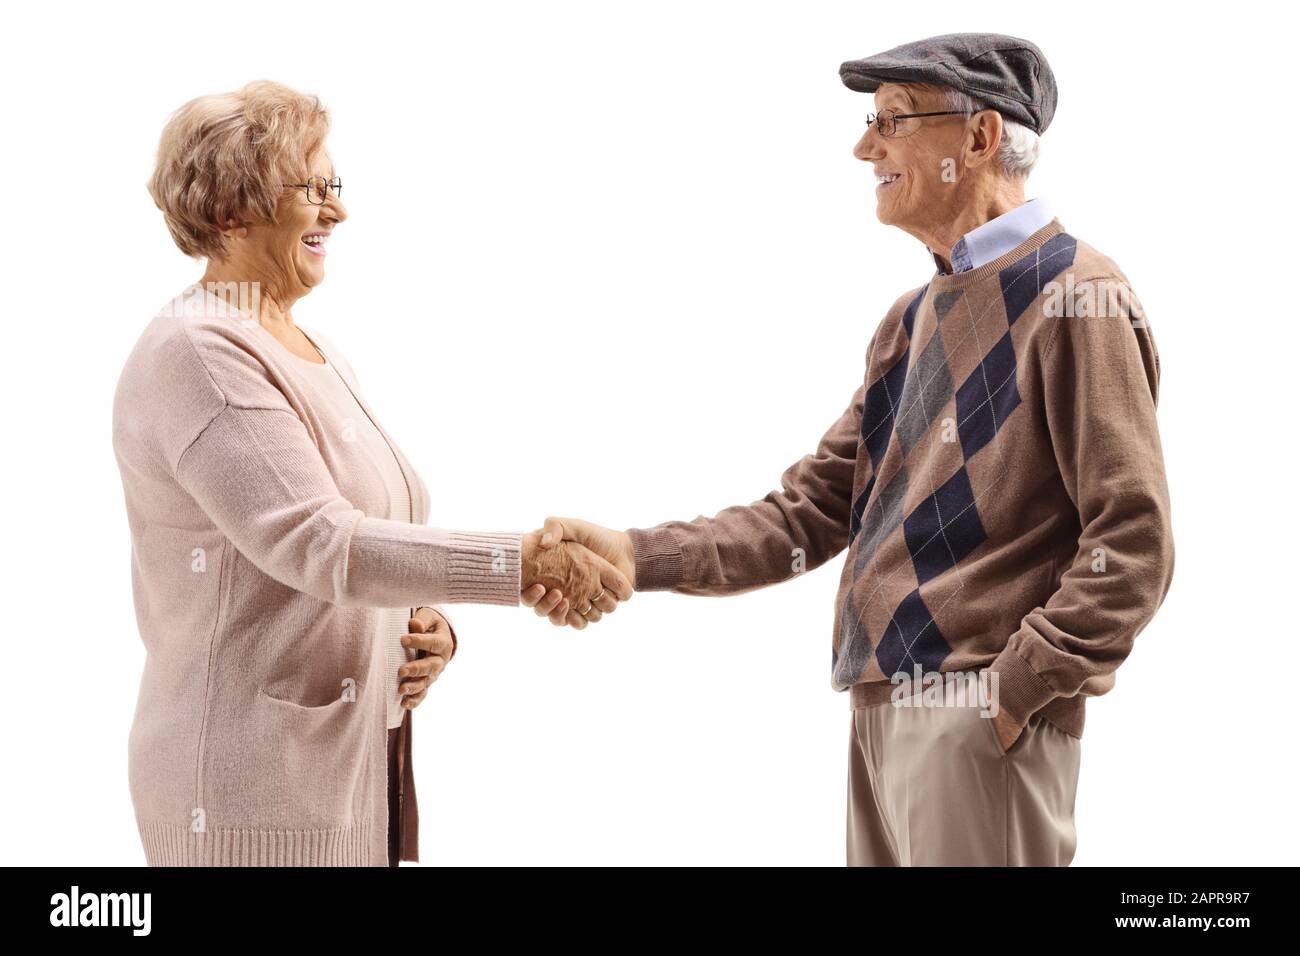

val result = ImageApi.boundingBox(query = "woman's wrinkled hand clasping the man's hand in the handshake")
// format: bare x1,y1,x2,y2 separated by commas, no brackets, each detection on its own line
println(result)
520,531,632,631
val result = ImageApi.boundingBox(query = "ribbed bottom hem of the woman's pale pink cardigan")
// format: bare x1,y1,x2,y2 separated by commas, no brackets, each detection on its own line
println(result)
137,819,387,866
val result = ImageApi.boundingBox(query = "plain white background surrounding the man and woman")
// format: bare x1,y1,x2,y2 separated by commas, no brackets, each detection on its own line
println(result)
0,0,1297,866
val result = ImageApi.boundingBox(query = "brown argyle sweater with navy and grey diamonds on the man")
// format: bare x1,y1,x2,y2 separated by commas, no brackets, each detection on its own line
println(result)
628,219,1174,736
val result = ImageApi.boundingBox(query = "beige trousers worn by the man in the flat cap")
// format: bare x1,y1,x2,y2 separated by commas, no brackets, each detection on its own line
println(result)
848,702,1082,866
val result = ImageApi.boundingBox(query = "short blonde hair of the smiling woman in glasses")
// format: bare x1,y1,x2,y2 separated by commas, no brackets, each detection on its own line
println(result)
148,79,329,259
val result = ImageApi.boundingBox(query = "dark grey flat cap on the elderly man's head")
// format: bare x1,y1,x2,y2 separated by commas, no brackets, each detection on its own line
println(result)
840,34,1056,133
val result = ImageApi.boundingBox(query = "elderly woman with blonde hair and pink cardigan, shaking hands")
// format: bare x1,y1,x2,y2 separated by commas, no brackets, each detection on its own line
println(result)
113,82,632,866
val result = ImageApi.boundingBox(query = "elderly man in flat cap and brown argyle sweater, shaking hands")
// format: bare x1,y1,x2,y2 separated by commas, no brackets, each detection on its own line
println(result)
525,34,1174,865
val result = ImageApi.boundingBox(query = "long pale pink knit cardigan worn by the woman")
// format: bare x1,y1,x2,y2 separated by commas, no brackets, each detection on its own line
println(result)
113,286,520,866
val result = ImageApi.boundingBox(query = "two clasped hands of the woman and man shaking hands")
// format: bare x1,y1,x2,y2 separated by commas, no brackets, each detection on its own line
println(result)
520,518,636,631
